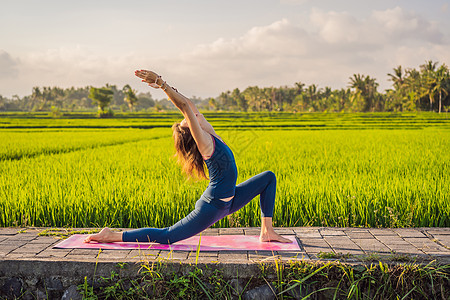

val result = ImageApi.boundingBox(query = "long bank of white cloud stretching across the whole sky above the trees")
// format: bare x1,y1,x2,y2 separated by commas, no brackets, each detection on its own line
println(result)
0,7,450,98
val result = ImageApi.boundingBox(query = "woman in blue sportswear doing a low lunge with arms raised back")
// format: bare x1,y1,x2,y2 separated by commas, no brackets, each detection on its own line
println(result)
85,70,291,244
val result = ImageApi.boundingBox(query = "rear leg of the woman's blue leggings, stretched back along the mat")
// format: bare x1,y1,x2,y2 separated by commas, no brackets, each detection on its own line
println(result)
122,199,227,244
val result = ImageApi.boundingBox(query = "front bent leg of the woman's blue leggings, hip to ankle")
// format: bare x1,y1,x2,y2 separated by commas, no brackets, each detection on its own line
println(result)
229,171,277,217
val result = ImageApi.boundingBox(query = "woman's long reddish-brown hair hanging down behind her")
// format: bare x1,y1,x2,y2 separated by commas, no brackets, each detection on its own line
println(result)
172,123,208,179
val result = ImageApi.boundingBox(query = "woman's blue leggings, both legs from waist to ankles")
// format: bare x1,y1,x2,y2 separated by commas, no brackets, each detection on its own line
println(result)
122,171,276,244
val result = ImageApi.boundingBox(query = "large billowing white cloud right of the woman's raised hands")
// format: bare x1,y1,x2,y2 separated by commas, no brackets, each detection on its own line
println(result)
155,8,450,95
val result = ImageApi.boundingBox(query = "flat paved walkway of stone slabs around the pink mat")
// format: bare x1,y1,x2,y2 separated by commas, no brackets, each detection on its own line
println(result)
0,227,450,264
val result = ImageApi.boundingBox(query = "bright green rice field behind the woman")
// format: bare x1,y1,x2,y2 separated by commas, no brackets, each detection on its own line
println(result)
0,112,450,227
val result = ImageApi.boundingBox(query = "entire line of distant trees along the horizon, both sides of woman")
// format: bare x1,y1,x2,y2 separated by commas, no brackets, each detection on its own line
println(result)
0,60,450,116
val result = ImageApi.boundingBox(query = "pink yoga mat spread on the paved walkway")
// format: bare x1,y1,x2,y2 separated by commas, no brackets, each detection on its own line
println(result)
53,234,300,251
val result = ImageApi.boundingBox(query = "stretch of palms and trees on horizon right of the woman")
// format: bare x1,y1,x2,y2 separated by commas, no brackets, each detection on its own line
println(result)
212,61,450,112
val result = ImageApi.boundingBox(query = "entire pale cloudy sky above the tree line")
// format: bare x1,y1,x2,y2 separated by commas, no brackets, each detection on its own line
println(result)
0,0,450,99
